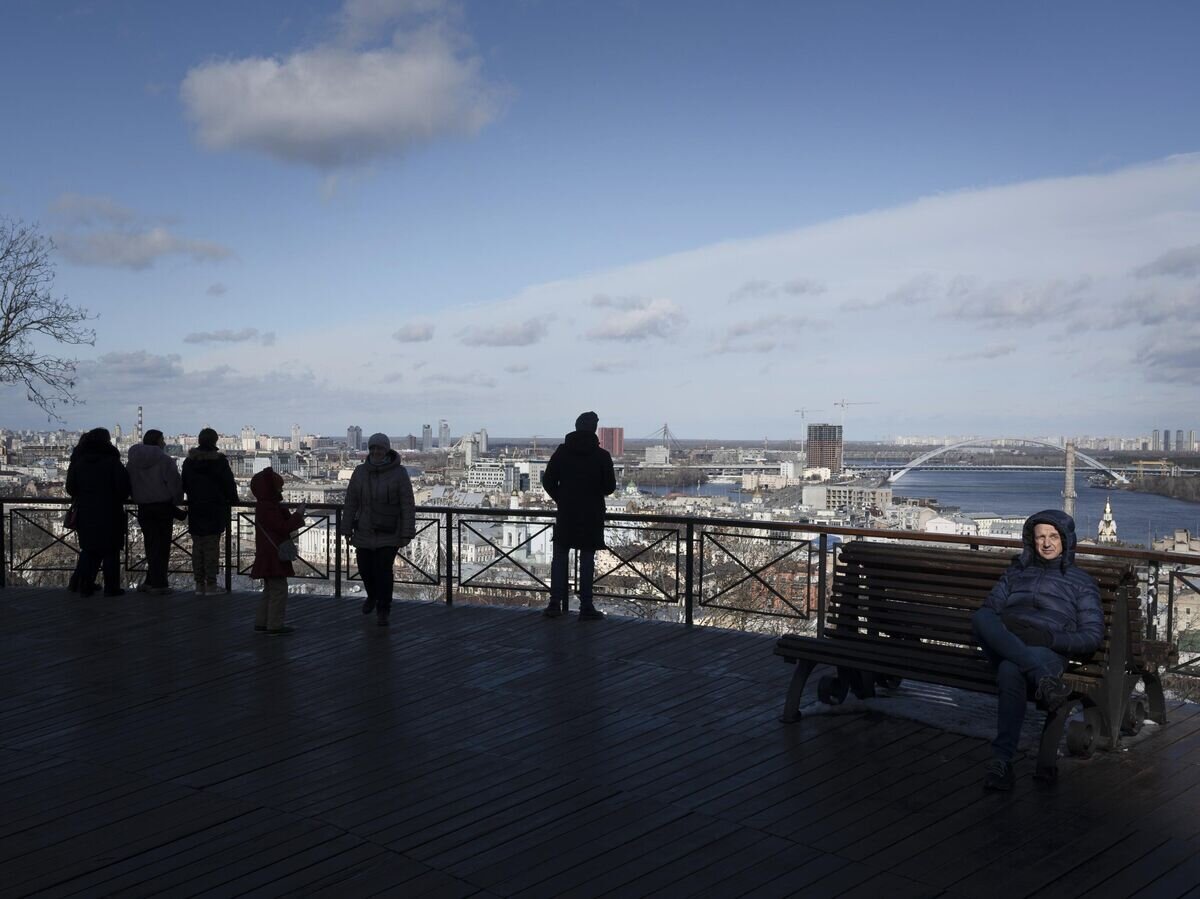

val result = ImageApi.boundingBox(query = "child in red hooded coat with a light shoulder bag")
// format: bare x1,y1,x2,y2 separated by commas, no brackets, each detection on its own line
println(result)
250,468,305,636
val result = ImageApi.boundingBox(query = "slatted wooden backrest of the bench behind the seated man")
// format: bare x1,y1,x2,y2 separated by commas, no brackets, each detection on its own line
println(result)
824,540,1144,681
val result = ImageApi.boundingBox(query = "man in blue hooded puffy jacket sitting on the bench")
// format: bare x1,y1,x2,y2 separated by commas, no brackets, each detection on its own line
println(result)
971,509,1104,790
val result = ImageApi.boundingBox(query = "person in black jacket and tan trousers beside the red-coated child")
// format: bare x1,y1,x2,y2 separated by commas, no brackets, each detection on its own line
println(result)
184,427,238,595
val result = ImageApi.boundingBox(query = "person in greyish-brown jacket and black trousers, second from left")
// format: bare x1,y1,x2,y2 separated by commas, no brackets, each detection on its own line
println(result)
125,428,184,597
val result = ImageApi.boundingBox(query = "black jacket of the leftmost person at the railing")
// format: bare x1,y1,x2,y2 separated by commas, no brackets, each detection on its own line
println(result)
66,438,130,552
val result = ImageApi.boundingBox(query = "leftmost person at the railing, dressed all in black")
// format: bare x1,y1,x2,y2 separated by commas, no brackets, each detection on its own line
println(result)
66,427,130,597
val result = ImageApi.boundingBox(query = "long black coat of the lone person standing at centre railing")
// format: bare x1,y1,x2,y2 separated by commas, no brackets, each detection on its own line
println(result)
541,431,617,550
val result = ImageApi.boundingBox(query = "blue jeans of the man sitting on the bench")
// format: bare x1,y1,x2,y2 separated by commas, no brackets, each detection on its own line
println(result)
971,609,1067,762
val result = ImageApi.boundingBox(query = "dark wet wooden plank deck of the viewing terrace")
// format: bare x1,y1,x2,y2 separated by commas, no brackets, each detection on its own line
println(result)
0,588,1200,899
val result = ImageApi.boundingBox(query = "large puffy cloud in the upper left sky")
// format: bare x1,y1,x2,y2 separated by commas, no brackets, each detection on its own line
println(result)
180,2,502,172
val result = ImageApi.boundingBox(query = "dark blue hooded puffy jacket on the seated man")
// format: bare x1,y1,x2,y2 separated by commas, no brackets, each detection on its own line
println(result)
984,509,1104,655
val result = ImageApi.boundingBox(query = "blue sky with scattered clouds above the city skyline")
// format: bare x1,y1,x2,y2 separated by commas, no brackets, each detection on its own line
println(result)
0,0,1200,440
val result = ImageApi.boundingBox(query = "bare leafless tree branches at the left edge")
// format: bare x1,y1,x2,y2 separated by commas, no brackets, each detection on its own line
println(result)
0,218,96,418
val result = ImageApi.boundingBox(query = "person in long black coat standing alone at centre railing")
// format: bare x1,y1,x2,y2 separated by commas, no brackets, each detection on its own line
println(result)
541,412,617,621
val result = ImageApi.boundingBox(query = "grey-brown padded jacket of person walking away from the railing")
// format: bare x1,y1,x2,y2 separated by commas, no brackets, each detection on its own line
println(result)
342,450,416,550
